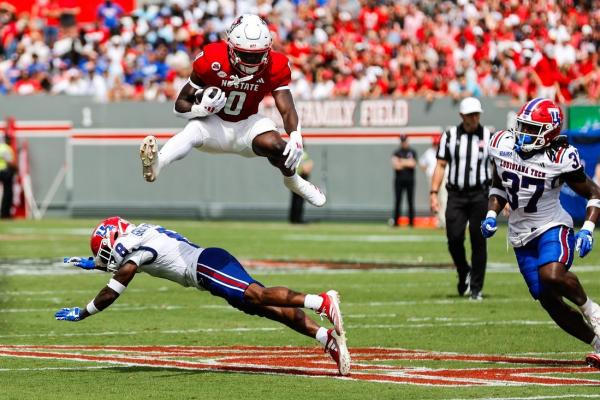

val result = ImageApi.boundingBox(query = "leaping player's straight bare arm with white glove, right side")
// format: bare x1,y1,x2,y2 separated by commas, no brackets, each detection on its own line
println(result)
272,89,304,170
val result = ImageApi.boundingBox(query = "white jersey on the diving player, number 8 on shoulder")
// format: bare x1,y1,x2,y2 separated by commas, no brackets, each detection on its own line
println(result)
107,224,204,289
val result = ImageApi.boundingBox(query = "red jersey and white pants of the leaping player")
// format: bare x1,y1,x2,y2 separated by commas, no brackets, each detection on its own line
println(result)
178,42,291,157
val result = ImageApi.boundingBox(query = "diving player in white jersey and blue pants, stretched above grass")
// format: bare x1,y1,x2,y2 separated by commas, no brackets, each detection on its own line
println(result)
55,217,350,375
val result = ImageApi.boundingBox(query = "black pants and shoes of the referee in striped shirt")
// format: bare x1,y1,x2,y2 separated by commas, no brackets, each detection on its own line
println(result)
446,190,488,293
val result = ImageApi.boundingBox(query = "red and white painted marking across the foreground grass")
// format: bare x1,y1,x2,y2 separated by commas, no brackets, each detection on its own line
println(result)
0,345,600,386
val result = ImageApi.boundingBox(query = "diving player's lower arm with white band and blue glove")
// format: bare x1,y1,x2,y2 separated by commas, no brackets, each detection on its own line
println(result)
54,262,137,322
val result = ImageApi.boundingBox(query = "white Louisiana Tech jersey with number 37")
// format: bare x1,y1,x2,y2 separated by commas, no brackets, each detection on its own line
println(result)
489,131,582,247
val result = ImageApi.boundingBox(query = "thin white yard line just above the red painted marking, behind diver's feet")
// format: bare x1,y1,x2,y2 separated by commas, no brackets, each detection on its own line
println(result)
0,320,554,338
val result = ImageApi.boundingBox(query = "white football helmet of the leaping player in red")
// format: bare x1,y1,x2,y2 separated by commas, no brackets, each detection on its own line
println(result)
227,14,273,75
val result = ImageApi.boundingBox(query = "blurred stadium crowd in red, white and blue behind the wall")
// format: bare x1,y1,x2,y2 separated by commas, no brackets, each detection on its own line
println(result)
0,0,600,103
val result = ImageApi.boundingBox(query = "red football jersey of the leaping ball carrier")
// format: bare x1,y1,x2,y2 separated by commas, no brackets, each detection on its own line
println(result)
194,42,292,122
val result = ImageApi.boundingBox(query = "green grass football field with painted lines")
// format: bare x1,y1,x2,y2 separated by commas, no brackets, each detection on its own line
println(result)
0,219,600,399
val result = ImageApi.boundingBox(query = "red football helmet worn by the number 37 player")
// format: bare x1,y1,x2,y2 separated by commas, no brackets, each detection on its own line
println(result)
512,98,563,153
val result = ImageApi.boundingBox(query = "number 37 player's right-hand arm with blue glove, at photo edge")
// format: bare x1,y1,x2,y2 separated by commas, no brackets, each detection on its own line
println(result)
564,172,600,257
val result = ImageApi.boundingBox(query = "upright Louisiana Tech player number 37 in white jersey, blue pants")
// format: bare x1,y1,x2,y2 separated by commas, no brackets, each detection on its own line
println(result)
481,98,600,368
